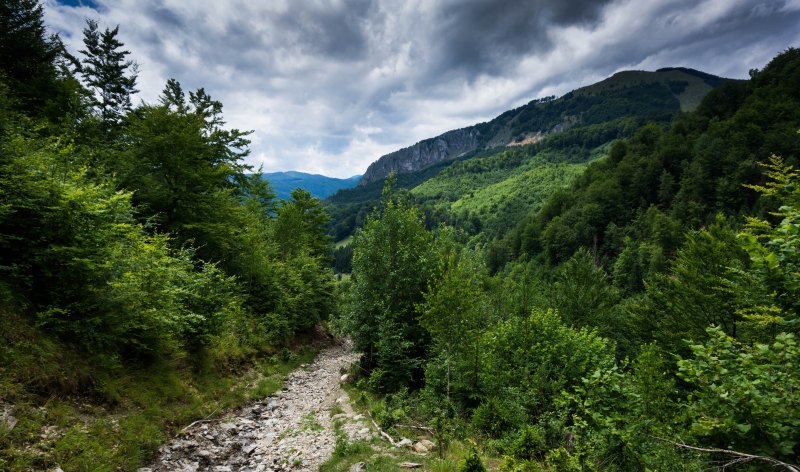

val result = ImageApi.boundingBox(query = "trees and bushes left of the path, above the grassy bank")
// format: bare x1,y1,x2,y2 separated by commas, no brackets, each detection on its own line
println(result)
0,0,334,384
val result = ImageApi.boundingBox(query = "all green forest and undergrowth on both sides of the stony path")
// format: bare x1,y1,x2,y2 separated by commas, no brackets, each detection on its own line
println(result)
0,0,800,471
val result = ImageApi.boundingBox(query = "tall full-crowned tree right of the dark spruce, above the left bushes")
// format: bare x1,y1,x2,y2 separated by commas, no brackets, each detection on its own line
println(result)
118,79,250,247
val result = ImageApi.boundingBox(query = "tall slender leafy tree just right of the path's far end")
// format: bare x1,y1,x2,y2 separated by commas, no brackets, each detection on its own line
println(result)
343,178,431,391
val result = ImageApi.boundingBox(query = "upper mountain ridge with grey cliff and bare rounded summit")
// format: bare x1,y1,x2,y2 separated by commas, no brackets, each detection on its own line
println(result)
359,68,725,186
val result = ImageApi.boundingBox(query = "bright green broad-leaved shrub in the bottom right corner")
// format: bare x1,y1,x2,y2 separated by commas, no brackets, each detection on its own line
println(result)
678,328,800,460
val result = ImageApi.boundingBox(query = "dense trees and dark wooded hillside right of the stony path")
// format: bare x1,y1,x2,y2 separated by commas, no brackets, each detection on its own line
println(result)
336,49,800,471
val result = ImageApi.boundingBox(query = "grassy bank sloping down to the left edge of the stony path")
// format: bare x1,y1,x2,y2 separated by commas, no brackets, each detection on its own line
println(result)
0,312,319,471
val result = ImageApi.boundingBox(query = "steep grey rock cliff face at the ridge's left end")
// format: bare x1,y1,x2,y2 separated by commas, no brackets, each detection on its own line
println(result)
359,126,481,185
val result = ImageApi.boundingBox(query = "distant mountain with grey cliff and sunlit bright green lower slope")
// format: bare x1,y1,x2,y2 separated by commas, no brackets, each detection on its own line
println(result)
325,68,726,247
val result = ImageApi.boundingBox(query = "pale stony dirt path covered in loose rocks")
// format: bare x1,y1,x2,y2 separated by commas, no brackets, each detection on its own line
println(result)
139,345,363,472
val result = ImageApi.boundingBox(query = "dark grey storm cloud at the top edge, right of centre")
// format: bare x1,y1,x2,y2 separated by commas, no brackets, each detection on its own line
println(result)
433,0,610,75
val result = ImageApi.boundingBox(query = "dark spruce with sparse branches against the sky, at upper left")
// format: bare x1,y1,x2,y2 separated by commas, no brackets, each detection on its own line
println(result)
81,19,138,131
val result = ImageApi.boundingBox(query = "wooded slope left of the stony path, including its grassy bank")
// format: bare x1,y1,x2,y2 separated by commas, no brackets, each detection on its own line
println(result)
0,0,335,470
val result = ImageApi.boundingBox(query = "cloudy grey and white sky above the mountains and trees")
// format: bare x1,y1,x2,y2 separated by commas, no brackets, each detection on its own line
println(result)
43,0,800,177
